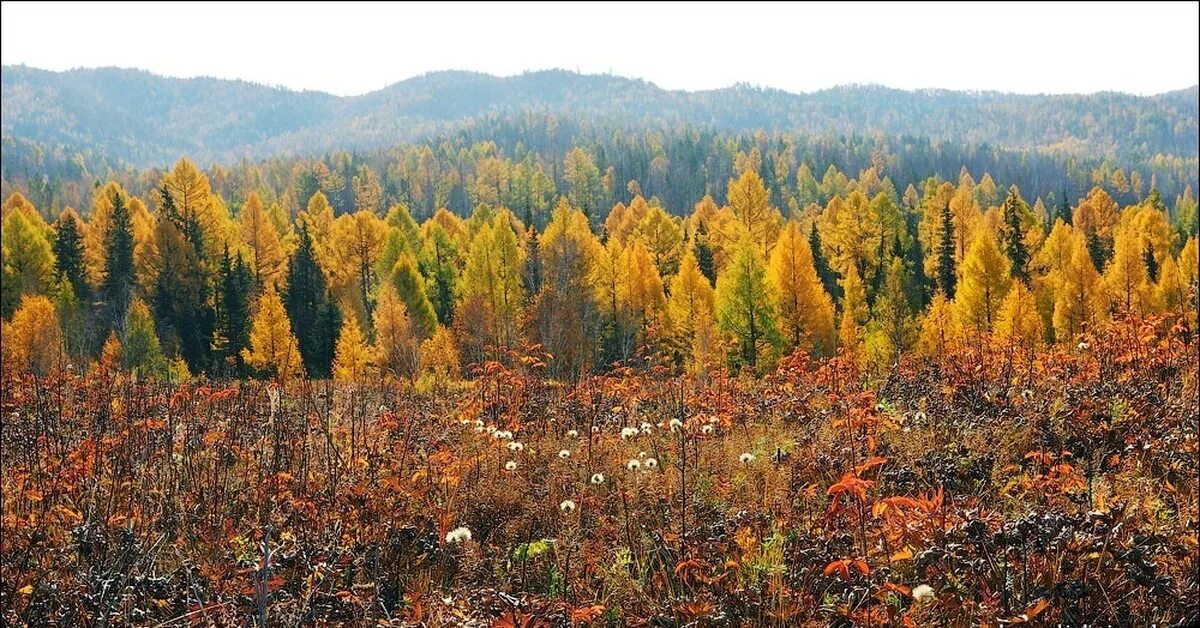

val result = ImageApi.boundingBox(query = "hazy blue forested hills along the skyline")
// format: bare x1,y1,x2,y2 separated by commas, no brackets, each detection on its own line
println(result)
2,66,1200,167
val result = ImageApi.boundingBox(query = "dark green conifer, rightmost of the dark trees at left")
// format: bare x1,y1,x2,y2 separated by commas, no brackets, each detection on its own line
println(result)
283,222,342,377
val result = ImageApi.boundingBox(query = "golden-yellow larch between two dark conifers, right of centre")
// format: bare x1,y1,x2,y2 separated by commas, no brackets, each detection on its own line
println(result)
954,228,1013,333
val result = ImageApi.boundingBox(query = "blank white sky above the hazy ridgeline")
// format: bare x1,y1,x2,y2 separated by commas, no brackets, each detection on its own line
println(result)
0,2,1200,96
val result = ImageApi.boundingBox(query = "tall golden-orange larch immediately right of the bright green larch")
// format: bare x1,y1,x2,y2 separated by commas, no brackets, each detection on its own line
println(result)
767,221,835,355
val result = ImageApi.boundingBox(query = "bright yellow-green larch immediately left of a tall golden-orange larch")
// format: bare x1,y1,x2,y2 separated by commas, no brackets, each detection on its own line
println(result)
716,238,780,369
